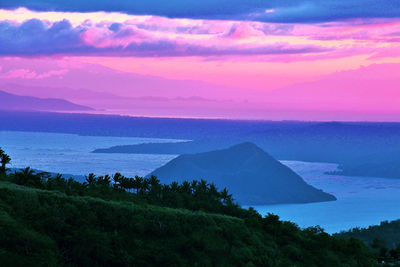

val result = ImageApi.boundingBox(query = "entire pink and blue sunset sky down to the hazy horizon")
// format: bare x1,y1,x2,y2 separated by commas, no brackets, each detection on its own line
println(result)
0,0,400,121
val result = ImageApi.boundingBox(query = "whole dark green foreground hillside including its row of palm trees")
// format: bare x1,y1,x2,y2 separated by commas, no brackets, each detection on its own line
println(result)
0,152,384,266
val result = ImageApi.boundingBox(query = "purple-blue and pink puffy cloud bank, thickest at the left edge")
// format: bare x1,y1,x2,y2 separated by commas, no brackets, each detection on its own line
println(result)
0,18,329,57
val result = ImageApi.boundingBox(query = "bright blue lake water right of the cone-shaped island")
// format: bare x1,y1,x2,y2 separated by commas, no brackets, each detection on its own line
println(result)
254,161,400,233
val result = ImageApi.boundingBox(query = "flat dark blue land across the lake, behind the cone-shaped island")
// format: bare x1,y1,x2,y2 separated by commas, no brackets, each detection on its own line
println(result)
0,111,400,178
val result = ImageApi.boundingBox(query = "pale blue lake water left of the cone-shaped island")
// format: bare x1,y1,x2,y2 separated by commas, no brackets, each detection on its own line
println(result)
0,131,178,176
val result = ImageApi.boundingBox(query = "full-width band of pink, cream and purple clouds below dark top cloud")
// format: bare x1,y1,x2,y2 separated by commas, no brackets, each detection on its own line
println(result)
0,9,400,58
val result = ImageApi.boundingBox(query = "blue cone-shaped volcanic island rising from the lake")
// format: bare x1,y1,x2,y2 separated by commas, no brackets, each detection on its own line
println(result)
149,142,336,205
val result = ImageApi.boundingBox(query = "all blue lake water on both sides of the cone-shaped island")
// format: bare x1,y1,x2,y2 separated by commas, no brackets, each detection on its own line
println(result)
0,131,400,233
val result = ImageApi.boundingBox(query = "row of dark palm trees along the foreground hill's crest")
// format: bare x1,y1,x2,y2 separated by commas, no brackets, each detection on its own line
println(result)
8,167,246,220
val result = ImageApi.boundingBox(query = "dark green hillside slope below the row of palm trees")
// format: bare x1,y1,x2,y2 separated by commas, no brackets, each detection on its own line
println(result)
0,182,374,266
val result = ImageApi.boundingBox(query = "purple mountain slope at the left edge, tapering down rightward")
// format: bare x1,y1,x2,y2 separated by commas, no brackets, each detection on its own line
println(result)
0,91,93,111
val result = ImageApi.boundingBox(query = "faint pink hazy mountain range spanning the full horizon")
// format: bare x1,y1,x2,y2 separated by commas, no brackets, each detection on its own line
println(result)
0,60,400,121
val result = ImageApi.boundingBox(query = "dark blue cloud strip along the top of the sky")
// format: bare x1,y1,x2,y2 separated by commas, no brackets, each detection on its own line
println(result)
0,0,400,23
